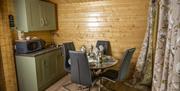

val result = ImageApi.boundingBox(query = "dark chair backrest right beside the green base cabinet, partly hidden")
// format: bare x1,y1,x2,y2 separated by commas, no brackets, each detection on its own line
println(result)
63,42,75,72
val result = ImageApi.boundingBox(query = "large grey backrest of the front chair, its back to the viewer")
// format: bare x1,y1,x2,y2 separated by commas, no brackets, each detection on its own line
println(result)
70,51,92,86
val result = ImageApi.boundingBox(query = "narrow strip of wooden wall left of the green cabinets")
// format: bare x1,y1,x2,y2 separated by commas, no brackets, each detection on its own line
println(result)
0,0,17,91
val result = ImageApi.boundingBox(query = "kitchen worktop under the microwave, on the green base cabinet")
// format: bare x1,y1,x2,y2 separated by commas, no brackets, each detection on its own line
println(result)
16,47,61,57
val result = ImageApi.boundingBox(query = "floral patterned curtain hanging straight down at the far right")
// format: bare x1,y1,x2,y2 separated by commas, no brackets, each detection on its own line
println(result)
152,0,180,91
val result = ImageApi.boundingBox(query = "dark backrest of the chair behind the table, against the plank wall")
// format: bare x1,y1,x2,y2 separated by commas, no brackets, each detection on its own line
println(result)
96,40,111,55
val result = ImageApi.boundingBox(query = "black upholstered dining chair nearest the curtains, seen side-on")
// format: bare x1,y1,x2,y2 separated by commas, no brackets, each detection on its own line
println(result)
101,48,136,82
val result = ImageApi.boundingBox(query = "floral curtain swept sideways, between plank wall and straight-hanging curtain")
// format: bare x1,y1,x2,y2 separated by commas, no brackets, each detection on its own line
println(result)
128,0,158,89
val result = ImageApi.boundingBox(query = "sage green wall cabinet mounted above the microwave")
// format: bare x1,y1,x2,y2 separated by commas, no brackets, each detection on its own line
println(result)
15,0,56,32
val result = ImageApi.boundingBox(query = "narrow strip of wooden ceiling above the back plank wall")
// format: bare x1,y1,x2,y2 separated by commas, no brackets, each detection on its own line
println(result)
54,0,105,4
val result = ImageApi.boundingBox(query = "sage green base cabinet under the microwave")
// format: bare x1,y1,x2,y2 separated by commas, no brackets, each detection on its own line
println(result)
16,48,66,91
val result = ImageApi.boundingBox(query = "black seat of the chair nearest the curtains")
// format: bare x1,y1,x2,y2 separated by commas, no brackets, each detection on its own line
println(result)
101,69,118,81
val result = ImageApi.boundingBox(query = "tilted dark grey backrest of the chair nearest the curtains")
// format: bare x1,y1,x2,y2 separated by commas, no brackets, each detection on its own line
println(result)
117,48,136,81
